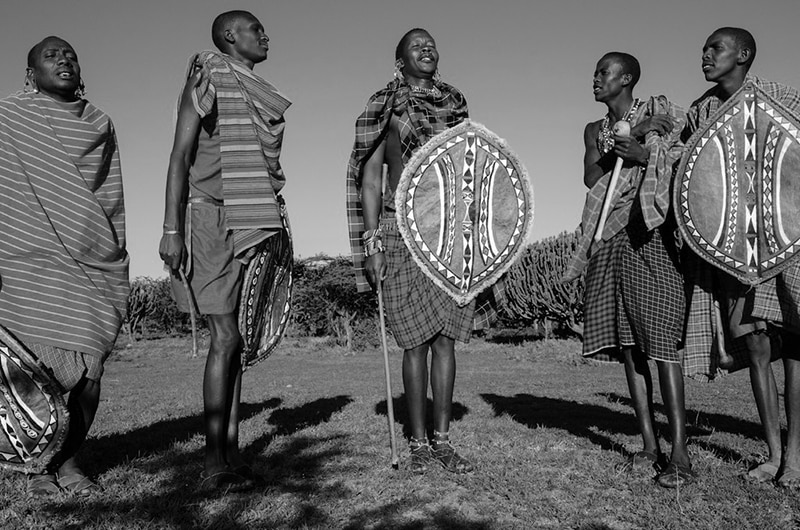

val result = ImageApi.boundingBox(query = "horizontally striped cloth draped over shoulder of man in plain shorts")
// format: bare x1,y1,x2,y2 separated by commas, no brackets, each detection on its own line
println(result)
184,51,291,257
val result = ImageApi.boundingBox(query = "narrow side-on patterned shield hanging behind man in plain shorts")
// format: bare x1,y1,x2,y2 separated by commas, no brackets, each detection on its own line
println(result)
239,203,294,367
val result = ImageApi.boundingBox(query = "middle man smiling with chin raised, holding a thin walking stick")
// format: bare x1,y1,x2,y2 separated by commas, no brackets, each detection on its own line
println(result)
347,29,475,473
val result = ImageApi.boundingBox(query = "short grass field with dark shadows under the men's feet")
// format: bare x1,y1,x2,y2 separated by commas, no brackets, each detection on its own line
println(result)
0,338,800,530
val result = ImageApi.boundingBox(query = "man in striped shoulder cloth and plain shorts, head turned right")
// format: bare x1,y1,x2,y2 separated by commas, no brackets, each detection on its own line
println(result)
160,11,290,490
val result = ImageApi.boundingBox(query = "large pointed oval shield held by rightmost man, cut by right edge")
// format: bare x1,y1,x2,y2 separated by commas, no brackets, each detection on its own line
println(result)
674,81,800,285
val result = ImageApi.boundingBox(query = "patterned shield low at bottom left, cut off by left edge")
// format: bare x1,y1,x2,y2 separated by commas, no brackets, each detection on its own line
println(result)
0,326,69,473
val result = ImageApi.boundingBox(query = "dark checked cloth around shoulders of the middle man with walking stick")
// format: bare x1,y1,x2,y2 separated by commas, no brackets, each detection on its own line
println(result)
346,79,469,292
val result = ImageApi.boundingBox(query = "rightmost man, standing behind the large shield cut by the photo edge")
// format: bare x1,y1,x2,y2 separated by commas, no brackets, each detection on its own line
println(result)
684,28,800,487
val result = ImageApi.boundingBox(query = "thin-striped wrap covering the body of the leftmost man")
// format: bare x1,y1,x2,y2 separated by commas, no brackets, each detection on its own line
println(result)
0,94,129,357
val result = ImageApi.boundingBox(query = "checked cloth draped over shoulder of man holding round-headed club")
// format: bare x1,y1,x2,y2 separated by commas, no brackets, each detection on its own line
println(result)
564,96,686,282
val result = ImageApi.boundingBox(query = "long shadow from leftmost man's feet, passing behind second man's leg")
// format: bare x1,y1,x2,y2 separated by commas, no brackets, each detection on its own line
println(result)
81,398,282,473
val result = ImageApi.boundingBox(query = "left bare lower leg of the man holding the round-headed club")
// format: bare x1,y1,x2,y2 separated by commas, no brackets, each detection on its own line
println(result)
622,342,661,466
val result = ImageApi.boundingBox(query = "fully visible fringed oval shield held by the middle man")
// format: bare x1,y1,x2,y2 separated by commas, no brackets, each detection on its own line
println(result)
395,120,533,305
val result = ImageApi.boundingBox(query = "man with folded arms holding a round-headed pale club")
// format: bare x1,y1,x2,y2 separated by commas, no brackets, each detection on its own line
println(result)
566,52,694,487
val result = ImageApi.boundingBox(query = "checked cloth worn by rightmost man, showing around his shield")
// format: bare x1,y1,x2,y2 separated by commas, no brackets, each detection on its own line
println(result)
683,74,800,379
